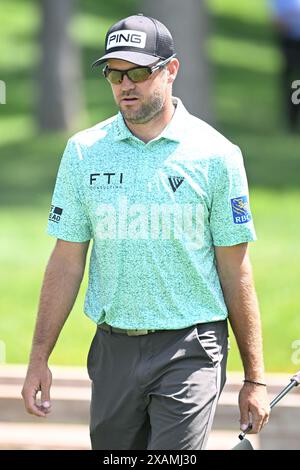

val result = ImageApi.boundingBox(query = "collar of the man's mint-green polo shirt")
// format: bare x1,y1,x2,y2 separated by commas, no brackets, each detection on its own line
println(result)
114,97,190,142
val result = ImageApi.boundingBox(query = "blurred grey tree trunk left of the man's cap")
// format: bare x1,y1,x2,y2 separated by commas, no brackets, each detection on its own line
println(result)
37,0,83,132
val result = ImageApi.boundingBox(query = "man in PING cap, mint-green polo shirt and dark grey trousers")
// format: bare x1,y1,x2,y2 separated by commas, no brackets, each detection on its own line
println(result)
23,15,269,450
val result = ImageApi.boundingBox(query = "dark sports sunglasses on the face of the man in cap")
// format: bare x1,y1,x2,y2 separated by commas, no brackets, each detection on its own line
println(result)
103,55,174,85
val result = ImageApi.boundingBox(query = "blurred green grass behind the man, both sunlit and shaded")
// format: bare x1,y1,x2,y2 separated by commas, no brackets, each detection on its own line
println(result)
0,0,300,371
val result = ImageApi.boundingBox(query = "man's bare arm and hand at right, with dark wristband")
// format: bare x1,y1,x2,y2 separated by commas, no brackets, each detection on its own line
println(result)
215,243,269,433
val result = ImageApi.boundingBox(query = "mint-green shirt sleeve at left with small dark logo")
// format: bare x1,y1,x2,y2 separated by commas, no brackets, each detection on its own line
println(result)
47,140,92,242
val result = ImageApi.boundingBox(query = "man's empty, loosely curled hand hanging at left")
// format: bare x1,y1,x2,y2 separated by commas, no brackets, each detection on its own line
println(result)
22,364,52,418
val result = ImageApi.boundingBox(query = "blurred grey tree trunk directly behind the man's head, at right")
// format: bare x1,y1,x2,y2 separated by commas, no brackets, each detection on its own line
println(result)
140,0,214,124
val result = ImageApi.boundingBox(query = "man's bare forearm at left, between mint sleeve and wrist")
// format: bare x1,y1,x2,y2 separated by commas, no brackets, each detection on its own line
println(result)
30,248,84,364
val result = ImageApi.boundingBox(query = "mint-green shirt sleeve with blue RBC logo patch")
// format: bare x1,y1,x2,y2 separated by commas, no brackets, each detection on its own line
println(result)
210,146,256,246
